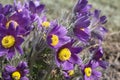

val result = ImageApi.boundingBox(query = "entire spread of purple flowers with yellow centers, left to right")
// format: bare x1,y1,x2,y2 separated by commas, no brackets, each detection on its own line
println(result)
0,0,108,80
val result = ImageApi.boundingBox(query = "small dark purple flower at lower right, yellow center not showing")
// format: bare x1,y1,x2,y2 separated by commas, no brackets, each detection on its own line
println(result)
91,46,108,69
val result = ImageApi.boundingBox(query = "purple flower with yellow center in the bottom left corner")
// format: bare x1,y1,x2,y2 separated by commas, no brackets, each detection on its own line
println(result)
2,62,29,80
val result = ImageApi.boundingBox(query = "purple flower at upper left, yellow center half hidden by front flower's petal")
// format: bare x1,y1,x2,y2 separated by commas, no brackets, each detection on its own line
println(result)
6,9,33,35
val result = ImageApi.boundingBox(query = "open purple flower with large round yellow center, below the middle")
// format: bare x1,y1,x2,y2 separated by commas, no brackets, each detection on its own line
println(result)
55,41,82,70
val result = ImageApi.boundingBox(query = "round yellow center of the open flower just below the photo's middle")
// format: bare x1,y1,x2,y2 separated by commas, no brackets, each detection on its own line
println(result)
58,48,71,61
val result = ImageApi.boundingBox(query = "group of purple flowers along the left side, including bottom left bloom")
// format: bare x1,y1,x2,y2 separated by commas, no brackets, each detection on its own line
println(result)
0,1,45,80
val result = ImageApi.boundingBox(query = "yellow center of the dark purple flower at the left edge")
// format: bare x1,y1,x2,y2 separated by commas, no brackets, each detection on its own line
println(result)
2,35,15,48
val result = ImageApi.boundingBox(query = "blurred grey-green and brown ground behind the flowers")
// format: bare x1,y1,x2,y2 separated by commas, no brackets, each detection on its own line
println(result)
0,0,120,80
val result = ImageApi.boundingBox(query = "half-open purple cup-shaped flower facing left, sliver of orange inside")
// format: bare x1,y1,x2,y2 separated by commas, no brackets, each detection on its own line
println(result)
73,16,90,42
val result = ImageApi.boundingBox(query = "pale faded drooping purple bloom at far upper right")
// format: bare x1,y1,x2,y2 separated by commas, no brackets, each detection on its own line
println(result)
91,10,108,40
